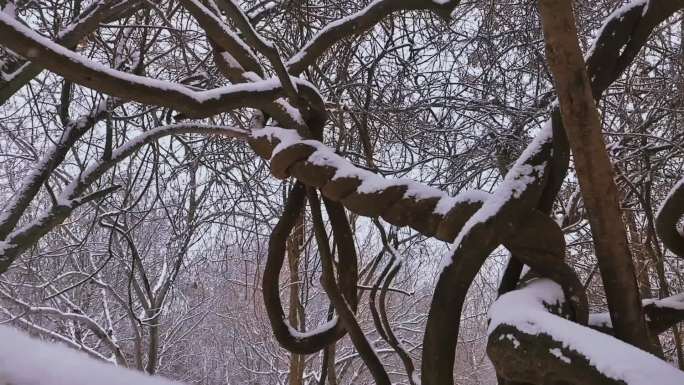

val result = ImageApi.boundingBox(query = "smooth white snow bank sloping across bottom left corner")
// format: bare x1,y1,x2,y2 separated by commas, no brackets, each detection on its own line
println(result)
0,326,180,385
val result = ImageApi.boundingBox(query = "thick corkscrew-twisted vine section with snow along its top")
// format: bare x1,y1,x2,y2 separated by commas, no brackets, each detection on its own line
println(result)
250,127,489,241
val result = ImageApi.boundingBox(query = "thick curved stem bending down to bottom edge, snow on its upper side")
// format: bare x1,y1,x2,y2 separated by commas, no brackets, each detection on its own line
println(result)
422,123,553,385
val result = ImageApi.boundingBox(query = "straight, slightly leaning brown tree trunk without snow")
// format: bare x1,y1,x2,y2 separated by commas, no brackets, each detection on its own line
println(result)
539,0,652,351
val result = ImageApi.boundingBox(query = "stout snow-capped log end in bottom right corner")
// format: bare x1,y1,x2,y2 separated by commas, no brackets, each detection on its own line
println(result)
487,279,684,385
